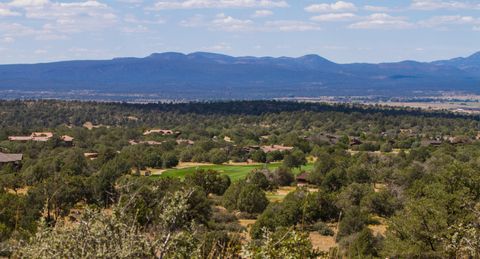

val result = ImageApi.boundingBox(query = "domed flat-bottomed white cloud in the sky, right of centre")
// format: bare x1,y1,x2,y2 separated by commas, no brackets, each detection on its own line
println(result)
348,13,414,29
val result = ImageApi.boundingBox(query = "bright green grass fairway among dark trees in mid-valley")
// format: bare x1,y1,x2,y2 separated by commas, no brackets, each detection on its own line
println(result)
152,163,313,181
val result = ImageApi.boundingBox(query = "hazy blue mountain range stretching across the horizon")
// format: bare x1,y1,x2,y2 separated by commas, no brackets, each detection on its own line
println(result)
0,52,480,99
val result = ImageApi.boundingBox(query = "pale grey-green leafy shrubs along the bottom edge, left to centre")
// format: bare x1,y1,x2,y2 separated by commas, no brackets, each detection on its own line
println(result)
12,190,318,259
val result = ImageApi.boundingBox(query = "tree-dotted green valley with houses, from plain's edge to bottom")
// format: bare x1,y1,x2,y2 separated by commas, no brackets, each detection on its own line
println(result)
0,101,480,258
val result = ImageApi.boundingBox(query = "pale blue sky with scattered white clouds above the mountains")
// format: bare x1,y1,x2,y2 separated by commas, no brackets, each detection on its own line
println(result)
0,0,480,64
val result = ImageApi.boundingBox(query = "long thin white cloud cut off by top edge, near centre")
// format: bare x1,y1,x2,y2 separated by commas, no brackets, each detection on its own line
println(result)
151,0,288,10
